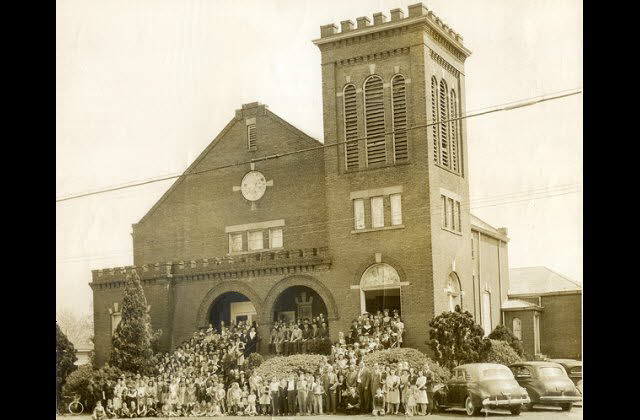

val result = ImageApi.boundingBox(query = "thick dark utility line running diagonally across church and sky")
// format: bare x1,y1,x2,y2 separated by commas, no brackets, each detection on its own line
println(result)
56,88,582,203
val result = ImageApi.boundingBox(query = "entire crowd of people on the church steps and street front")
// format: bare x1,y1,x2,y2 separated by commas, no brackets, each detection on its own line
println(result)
93,311,430,419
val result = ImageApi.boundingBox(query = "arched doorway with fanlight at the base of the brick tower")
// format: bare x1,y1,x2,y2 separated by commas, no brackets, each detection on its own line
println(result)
360,263,402,314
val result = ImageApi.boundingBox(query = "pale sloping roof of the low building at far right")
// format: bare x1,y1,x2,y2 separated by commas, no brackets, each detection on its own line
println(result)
508,266,582,297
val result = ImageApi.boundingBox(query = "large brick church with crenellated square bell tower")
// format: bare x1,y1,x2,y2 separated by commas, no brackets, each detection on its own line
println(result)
90,3,509,364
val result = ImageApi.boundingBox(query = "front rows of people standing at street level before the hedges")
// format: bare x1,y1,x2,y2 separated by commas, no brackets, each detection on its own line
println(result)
93,357,431,419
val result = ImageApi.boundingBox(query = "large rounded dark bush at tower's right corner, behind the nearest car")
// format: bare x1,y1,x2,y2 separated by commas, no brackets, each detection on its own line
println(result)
429,311,491,369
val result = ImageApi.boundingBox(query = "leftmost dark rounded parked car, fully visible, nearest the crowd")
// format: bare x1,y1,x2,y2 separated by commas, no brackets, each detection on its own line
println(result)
433,363,531,416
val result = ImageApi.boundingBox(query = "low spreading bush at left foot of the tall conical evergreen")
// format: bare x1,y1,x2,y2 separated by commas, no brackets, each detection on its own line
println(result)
62,364,123,411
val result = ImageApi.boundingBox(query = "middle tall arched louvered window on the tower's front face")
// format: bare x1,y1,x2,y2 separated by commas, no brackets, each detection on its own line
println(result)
364,76,387,165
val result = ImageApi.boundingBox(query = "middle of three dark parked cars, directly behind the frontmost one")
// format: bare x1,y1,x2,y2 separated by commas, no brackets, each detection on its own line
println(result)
509,362,582,411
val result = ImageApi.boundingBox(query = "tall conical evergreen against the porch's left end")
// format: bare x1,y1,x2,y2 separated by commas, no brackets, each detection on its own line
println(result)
109,274,155,374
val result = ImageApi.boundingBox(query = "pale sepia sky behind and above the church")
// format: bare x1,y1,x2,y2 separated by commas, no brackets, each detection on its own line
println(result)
56,0,583,314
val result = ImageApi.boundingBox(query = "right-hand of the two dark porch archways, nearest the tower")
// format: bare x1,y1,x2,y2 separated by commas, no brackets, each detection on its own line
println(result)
270,285,329,322
